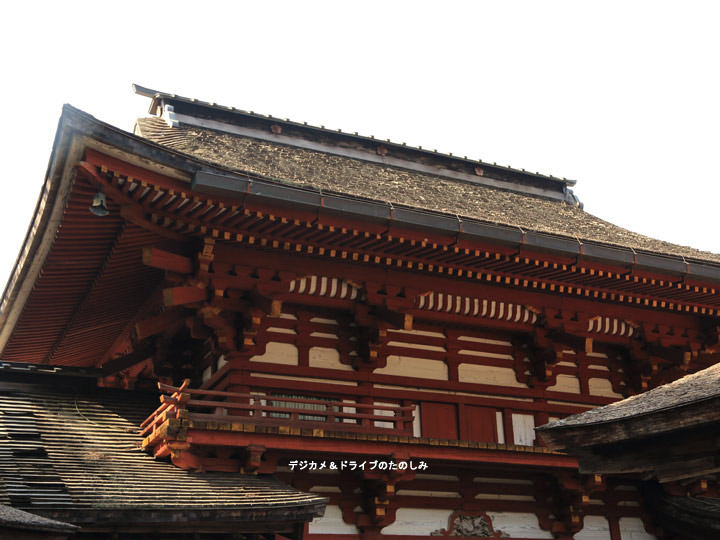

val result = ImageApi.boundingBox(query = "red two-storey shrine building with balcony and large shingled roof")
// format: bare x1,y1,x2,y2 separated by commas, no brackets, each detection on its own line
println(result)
0,87,720,540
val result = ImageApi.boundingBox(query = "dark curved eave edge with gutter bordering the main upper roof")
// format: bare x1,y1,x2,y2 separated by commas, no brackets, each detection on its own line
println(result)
0,105,720,358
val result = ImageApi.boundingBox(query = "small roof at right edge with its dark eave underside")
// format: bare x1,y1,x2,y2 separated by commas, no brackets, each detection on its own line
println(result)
535,364,720,486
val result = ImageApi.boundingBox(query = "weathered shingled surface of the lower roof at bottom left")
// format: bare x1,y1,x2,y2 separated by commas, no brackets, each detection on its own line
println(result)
0,387,326,512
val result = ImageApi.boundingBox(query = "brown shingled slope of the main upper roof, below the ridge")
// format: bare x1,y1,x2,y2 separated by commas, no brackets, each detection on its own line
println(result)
136,118,720,263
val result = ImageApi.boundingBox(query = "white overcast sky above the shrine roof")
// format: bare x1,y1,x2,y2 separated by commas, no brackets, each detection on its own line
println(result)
0,0,720,287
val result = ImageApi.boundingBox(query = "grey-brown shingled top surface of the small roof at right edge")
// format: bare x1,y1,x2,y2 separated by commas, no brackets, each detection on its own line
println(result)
538,364,720,431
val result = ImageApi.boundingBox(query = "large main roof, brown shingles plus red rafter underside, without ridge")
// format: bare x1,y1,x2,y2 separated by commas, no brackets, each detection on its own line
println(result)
0,100,720,367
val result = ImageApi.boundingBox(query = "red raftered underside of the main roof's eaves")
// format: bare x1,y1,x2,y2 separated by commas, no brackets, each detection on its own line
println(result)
2,110,720,378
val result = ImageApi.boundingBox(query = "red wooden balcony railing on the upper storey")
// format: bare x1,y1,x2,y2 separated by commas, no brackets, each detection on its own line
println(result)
140,380,415,437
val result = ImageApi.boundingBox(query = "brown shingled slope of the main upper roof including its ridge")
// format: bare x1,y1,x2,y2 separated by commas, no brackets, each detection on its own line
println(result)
135,94,720,263
